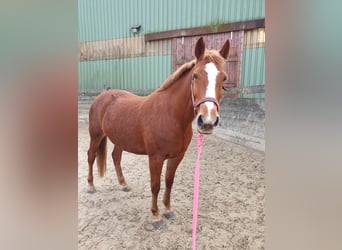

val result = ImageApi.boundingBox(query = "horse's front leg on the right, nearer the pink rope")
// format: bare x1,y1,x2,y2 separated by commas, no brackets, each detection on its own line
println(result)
163,153,184,219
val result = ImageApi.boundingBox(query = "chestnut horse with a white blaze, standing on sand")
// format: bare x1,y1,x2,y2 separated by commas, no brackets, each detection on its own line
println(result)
88,37,229,229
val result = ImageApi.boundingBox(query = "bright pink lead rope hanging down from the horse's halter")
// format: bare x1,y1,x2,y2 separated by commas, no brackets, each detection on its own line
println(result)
192,133,203,250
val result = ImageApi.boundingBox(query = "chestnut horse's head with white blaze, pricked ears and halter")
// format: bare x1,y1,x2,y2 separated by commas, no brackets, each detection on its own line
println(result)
191,37,229,134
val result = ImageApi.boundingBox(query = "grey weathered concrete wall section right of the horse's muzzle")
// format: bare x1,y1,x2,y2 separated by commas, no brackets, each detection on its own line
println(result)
214,98,265,151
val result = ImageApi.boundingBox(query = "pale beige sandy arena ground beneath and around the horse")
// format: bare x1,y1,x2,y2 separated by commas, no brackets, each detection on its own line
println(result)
78,106,265,250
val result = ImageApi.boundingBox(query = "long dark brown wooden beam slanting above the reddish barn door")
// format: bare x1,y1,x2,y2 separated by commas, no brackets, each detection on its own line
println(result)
145,18,265,41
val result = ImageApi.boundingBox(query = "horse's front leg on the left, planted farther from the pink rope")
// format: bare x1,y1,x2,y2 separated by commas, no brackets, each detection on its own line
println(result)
149,156,164,229
